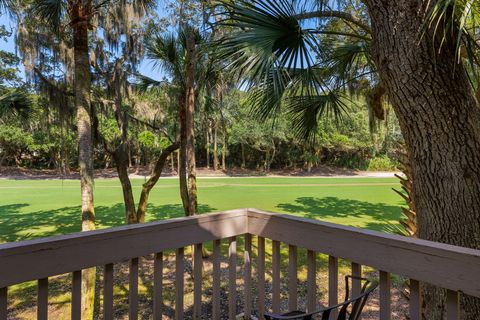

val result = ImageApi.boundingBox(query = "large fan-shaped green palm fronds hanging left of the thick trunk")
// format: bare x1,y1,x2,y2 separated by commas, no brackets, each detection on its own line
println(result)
217,0,345,139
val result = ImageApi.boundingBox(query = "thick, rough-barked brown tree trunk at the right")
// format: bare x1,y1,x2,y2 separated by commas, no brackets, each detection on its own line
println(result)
365,0,480,319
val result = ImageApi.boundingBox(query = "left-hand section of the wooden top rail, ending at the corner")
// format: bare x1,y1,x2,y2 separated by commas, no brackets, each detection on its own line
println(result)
0,209,247,288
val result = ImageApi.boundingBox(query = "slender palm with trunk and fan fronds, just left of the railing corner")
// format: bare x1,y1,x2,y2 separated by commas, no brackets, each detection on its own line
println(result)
140,26,202,215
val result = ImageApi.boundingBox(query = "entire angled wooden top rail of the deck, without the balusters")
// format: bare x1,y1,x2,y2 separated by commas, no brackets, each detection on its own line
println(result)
0,209,480,297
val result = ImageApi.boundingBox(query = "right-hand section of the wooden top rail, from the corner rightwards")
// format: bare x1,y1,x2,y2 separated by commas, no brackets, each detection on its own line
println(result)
248,209,480,297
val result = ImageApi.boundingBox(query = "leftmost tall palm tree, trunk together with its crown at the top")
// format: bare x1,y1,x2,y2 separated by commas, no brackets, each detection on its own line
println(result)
25,0,154,319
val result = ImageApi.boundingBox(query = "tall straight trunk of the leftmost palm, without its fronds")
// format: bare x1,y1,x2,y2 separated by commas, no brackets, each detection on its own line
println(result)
72,6,95,319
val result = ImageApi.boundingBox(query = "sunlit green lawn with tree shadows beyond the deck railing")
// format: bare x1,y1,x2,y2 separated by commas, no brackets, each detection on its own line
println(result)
0,178,402,243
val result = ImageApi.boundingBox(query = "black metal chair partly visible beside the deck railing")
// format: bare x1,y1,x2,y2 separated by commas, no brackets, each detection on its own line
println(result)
264,276,378,320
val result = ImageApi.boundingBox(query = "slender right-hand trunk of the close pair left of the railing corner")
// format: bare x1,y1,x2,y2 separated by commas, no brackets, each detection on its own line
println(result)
185,30,197,216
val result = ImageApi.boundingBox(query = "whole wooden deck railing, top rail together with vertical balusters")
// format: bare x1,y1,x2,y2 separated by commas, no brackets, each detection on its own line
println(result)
0,209,480,320
